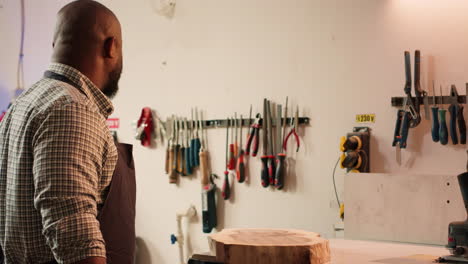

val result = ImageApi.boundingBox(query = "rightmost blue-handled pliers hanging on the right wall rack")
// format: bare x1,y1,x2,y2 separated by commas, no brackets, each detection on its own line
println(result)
449,85,466,145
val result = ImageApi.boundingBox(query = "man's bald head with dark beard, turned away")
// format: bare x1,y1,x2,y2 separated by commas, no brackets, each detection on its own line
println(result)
52,0,122,97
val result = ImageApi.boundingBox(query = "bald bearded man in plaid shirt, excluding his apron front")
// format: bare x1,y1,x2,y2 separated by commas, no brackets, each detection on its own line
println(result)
0,0,131,263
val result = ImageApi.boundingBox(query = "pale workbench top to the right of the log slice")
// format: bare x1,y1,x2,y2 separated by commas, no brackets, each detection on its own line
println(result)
329,239,449,264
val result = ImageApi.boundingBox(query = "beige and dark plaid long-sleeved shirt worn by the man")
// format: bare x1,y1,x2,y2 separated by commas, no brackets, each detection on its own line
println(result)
0,63,117,264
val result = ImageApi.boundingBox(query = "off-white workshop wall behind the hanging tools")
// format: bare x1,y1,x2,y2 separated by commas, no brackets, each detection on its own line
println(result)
0,0,468,263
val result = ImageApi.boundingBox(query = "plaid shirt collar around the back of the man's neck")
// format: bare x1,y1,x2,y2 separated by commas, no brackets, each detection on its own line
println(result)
48,62,114,118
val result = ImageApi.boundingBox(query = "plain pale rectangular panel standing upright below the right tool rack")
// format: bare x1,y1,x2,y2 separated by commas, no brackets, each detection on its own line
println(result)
345,174,466,245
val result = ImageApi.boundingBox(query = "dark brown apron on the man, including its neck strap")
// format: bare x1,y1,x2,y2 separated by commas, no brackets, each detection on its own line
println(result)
41,71,136,264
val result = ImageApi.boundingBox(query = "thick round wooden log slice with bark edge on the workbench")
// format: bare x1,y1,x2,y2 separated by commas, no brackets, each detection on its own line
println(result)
209,229,330,264
